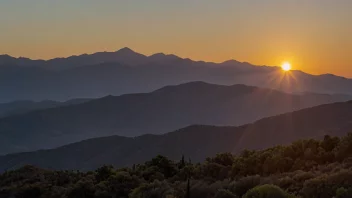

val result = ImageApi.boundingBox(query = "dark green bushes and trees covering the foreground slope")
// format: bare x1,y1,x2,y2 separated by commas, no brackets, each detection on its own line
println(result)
0,134,352,198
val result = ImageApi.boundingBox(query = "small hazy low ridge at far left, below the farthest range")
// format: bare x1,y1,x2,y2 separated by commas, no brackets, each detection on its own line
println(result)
0,98,91,118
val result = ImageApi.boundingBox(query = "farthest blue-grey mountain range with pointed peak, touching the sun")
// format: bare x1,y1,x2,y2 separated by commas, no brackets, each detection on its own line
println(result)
0,48,352,102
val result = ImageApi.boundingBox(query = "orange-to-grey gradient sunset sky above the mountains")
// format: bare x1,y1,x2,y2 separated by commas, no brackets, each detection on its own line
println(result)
0,0,352,77
